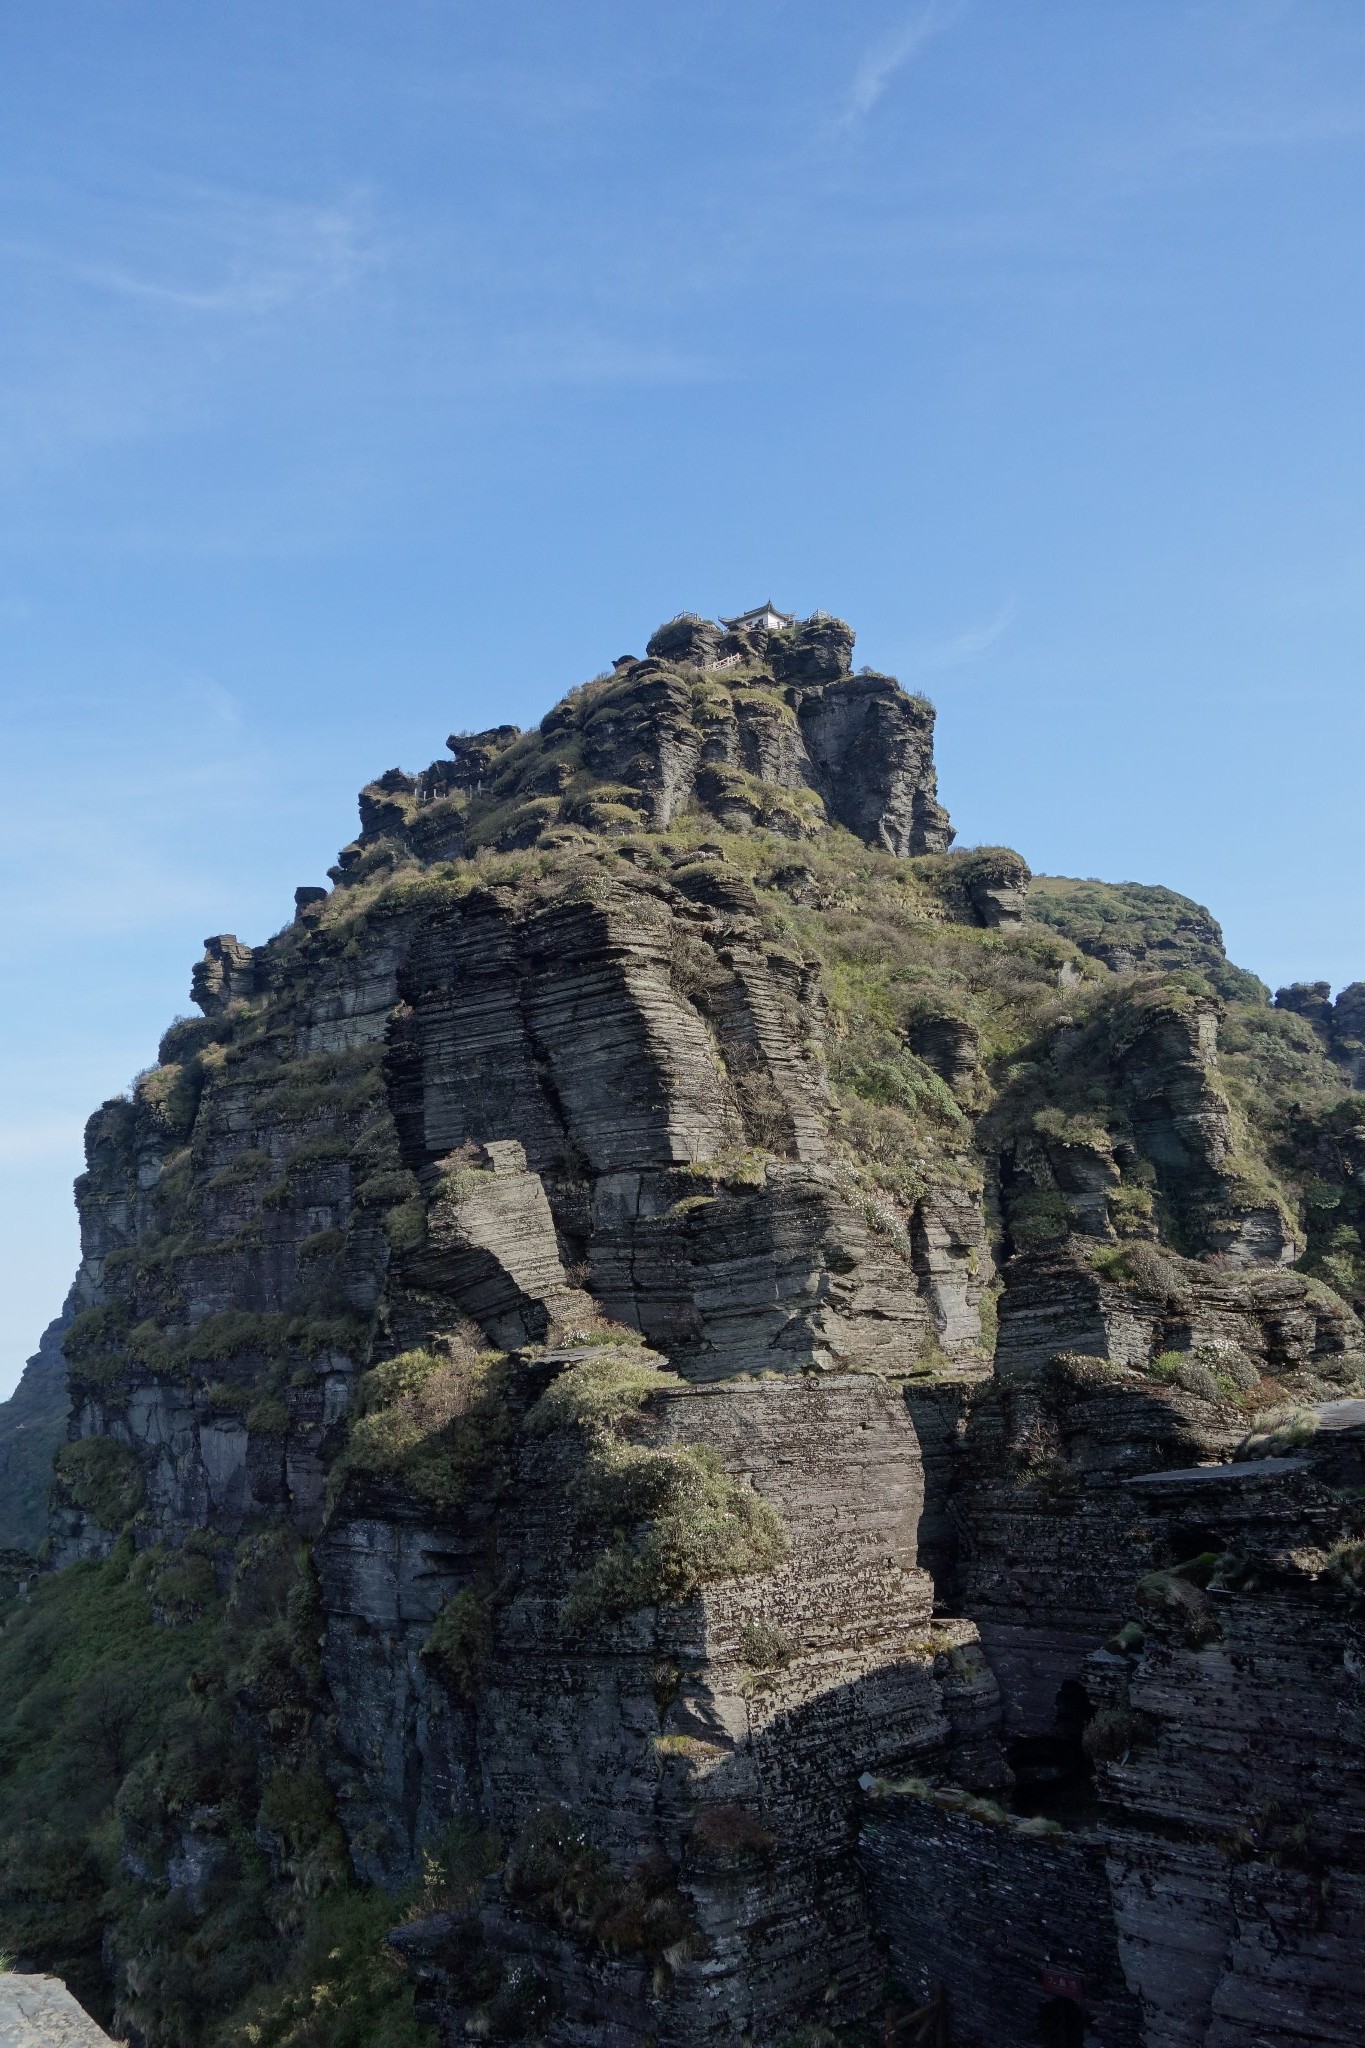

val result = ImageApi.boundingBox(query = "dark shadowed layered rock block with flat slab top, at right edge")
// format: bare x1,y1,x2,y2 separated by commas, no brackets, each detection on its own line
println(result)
1091,1401,1365,2048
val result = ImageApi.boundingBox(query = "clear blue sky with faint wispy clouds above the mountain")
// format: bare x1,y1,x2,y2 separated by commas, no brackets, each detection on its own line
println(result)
0,0,1365,1391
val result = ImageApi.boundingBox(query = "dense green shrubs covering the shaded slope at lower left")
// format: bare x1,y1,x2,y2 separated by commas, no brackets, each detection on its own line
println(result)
0,1499,434,2048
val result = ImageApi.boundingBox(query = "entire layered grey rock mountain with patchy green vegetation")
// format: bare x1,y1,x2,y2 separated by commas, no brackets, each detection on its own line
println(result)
0,614,1365,2048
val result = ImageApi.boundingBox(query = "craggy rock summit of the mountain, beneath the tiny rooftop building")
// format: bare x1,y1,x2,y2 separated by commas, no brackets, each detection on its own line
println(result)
334,614,954,864
